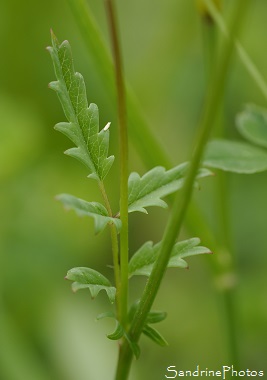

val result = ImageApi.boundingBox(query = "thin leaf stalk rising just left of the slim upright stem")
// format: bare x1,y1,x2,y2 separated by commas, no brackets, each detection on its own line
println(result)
98,181,122,319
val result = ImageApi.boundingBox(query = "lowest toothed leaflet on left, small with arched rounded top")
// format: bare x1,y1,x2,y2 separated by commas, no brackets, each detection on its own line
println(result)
65,267,116,303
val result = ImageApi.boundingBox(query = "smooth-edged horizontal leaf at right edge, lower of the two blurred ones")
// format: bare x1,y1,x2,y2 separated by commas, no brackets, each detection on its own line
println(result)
203,140,267,174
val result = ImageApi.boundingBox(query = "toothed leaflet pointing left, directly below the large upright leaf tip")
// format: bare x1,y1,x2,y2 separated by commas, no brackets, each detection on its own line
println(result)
57,194,121,233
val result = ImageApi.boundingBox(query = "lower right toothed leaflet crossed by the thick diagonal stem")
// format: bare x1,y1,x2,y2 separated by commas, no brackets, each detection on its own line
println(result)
129,238,211,277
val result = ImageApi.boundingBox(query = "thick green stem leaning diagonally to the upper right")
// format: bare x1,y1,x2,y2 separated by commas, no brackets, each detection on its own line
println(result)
116,0,244,380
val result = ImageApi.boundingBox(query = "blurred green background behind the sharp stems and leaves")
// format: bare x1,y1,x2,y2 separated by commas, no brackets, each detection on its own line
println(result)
0,0,267,380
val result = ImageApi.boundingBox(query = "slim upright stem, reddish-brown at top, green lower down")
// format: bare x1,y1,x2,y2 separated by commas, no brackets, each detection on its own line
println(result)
105,0,129,327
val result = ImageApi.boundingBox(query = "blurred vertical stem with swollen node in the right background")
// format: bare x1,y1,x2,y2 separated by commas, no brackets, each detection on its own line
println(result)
198,3,240,367
